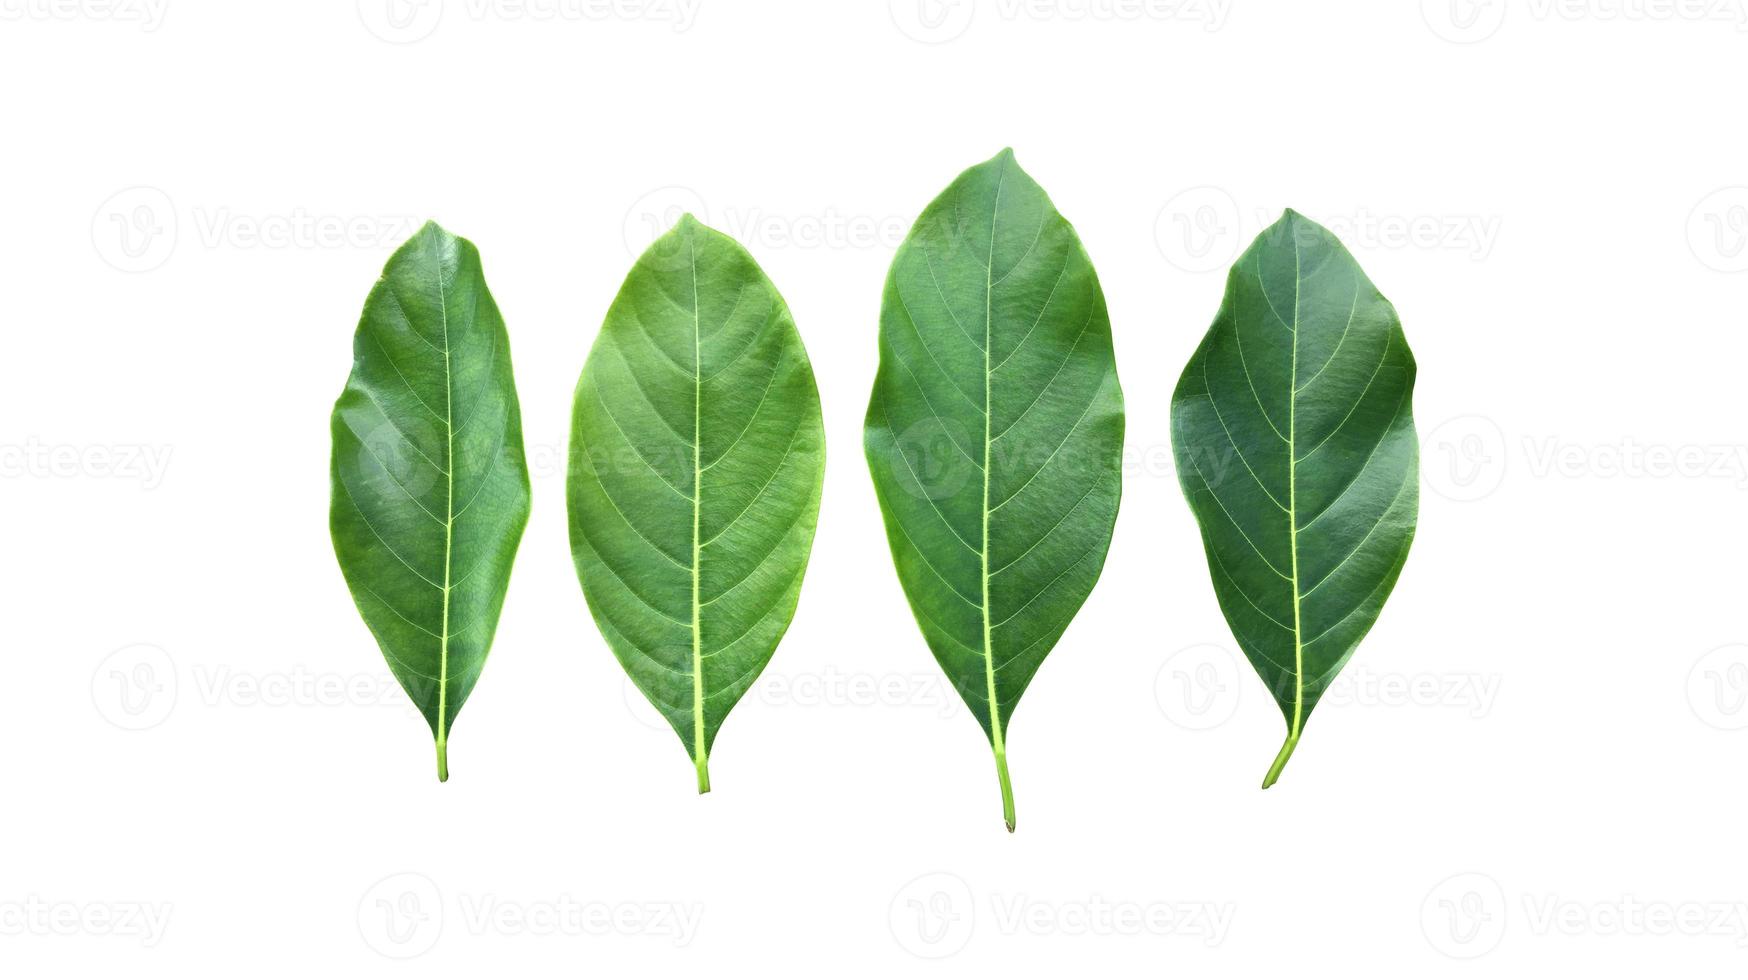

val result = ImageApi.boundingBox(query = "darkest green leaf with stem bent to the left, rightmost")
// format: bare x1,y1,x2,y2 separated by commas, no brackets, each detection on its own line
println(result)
1171,211,1419,788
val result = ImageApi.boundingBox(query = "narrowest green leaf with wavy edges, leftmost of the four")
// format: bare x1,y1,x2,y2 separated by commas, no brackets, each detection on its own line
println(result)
329,224,528,779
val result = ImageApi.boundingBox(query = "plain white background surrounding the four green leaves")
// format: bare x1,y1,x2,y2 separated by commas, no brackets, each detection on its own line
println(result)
0,0,1748,978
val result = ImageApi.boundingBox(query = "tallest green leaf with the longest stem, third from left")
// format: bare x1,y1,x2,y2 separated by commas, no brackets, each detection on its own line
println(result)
864,150,1122,830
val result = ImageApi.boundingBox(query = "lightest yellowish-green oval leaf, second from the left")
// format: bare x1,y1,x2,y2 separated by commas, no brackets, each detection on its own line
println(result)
568,215,825,793
